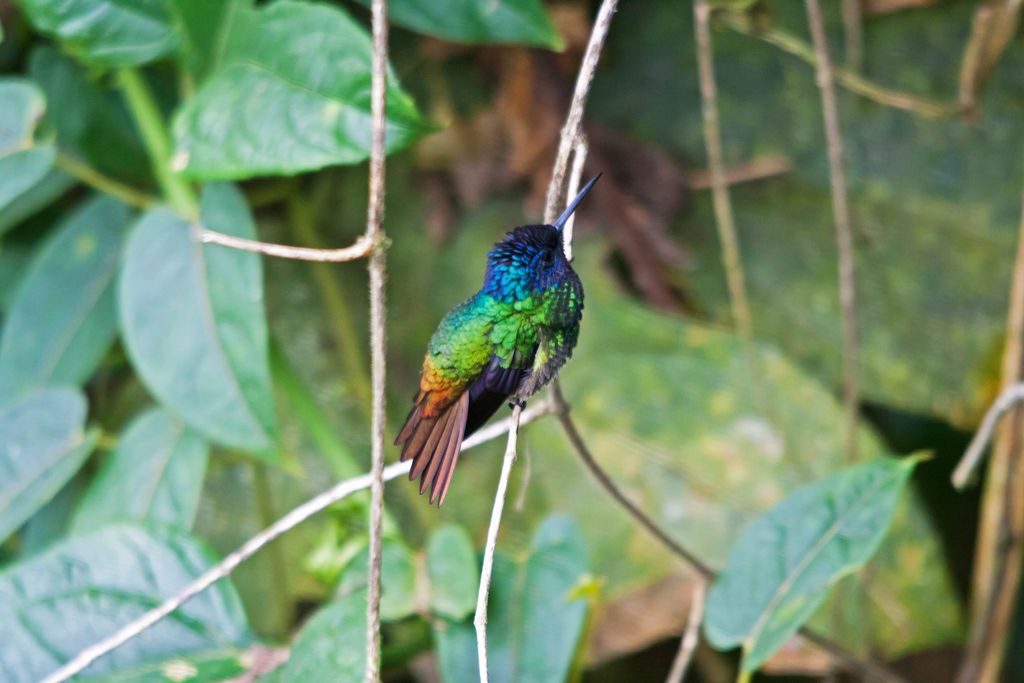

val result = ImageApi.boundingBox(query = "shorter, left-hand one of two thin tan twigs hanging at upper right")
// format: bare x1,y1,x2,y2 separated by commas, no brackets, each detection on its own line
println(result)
693,0,754,344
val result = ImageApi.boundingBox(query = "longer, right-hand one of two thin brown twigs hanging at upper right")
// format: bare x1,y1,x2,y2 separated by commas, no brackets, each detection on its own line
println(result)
807,0,859,462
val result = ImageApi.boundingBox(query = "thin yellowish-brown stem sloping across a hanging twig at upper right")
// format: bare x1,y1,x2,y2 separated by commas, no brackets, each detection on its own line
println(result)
715,10,966,119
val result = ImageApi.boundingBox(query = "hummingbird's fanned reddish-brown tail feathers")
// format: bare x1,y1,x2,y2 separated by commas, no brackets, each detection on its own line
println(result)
394,392,469,507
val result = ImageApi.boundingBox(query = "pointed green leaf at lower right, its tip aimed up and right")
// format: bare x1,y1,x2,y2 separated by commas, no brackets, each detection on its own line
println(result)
705,458,919,671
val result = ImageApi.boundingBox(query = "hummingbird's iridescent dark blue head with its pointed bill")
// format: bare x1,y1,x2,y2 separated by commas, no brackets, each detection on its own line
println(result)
483,174,601,302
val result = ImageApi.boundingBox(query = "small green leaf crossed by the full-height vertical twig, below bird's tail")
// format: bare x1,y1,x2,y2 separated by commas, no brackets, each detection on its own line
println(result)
338,538,416,622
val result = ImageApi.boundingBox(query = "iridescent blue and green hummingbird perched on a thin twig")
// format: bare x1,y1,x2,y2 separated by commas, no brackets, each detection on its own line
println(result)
394,173,601,507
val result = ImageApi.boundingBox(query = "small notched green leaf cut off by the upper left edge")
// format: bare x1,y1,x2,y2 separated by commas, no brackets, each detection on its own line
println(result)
0,78,56,219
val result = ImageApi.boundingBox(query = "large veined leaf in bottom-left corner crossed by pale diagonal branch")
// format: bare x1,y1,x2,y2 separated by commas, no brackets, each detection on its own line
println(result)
0,525,251,683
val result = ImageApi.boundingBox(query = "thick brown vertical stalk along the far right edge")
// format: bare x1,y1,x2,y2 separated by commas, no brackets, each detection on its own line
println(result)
956,189,1024,683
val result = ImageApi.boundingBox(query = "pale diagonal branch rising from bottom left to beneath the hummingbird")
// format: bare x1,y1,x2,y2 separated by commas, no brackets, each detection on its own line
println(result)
42,403,553,683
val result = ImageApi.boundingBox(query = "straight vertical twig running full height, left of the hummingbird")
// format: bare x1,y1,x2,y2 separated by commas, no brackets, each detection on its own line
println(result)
366,0,387,683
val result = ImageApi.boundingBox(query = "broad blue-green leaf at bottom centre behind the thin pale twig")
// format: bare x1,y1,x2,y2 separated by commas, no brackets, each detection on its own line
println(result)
434,516,588,683
